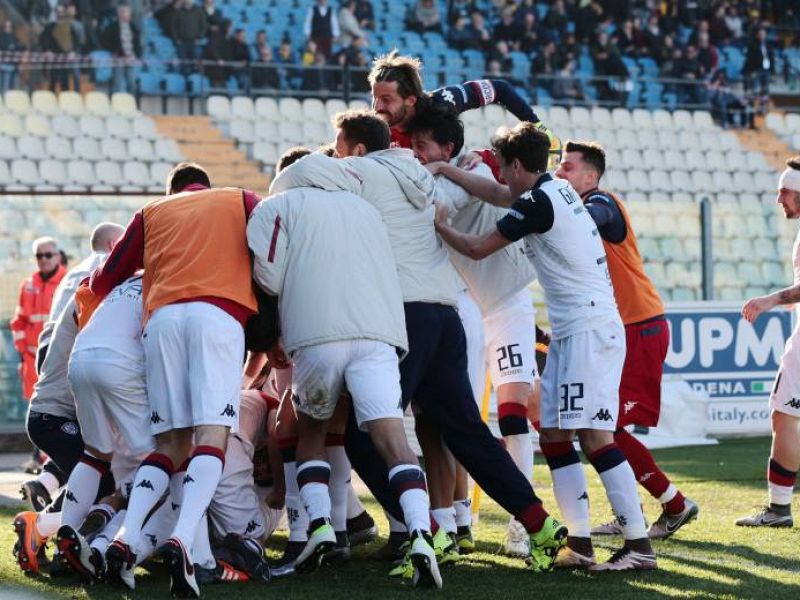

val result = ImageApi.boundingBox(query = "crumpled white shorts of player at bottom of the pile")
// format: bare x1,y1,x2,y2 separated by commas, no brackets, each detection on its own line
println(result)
208,434,277,540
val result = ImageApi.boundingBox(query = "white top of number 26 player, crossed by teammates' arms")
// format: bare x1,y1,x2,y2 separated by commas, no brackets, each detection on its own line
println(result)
436,159,536,317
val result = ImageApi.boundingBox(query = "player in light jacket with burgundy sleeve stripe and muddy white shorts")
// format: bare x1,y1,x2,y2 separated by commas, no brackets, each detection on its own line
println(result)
247,177,442,588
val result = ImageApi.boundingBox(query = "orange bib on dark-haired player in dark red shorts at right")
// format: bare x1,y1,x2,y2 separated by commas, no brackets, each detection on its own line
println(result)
588,191,664,325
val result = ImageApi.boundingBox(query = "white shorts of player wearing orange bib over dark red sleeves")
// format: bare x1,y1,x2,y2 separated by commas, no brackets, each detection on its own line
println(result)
143,302,244,435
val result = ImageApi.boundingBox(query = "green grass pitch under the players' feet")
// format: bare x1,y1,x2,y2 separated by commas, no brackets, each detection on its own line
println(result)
0,438,800,600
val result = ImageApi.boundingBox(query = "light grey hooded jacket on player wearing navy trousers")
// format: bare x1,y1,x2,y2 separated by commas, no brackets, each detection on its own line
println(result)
270,148,461,306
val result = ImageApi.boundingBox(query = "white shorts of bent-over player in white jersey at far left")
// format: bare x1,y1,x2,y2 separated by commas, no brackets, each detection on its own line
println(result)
68,348,155,455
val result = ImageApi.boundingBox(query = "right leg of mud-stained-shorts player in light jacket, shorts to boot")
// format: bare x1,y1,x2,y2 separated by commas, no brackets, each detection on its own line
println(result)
345,340,438,588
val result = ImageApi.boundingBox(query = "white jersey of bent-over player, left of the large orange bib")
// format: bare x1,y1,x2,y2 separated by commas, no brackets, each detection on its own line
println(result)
72,275,144,364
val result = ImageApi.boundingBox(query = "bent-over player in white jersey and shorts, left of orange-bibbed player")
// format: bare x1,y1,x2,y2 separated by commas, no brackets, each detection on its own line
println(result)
57,275,155,575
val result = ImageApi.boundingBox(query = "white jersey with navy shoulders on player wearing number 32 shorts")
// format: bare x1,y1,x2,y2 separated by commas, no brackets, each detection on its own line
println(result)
497,173,620,339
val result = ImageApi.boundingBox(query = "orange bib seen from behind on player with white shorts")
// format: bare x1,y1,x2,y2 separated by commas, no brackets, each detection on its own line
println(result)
142,188,258,319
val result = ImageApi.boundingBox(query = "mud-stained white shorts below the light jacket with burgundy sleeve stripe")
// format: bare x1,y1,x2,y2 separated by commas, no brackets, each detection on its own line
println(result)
292,340,403,430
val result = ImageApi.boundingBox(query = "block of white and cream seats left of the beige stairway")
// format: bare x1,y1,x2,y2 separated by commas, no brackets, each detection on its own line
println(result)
0,90,183,192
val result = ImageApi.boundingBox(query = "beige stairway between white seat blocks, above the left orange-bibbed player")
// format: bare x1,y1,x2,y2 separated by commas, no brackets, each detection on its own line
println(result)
153,115,270,196
